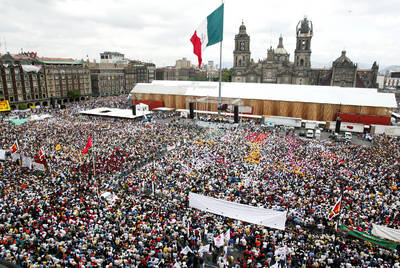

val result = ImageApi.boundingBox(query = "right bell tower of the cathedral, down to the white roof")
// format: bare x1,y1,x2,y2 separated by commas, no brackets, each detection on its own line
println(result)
293,17,313,85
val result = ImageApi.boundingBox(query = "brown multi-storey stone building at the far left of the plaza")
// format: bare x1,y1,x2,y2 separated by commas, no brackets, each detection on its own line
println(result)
0,52,91,109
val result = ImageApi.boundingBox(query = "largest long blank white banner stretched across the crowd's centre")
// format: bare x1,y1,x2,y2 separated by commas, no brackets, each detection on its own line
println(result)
189,193,287,230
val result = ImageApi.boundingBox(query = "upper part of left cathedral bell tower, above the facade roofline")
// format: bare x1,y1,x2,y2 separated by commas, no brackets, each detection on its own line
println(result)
233,21,250,68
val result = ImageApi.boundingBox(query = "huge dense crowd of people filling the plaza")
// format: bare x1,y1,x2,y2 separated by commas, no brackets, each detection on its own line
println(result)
0,96,400,268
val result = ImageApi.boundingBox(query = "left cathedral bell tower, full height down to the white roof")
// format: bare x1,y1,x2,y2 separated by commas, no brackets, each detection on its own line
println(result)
232,21,250,82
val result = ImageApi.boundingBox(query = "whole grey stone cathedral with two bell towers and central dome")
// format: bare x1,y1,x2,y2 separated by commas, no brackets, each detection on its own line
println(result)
232,18,379,88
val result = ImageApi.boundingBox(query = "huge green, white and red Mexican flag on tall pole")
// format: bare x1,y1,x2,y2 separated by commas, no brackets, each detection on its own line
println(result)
190,4,224,68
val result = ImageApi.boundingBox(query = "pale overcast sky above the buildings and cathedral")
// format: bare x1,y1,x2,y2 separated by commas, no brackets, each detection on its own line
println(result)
0,0,400,69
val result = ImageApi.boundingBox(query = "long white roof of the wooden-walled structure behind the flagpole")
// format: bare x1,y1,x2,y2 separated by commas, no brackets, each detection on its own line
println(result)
131,80,397,108
